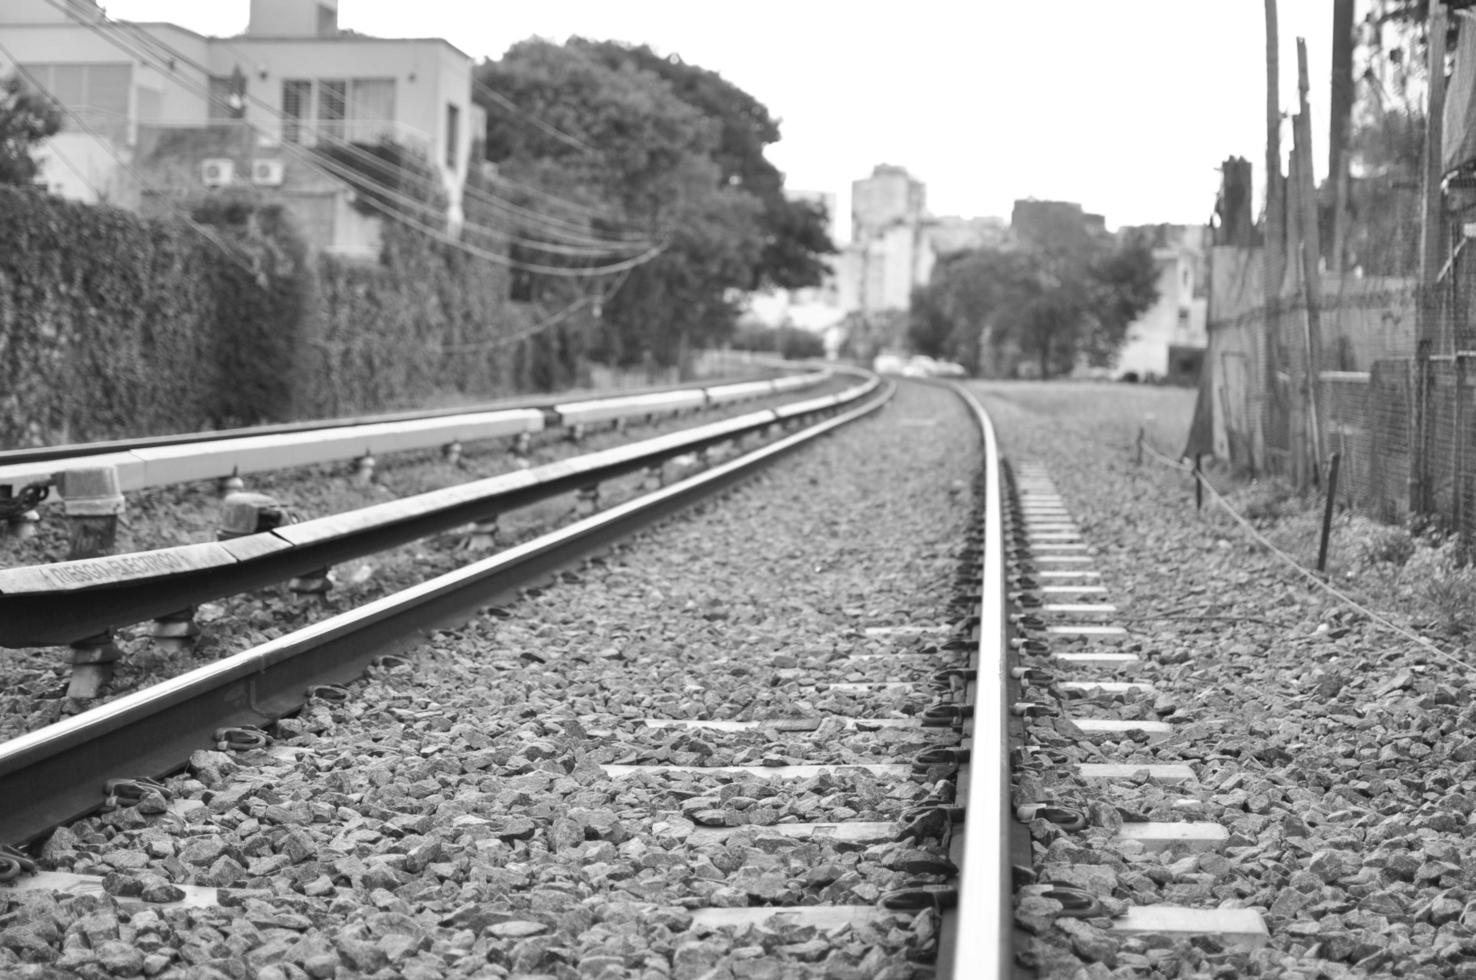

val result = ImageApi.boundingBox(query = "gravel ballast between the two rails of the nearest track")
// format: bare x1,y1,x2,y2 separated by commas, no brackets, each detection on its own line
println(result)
0,385,979,980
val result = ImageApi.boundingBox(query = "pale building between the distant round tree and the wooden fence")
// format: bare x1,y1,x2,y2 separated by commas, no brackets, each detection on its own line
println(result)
1114,224,1209,382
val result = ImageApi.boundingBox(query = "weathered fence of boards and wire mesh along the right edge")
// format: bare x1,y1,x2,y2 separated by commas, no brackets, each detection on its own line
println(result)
1207,205,1476,537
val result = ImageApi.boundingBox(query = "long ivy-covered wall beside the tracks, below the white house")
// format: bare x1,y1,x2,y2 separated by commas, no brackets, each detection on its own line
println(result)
0,187,587,449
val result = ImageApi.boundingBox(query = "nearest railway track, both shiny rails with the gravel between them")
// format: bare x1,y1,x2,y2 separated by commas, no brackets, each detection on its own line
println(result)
0,376,1033,977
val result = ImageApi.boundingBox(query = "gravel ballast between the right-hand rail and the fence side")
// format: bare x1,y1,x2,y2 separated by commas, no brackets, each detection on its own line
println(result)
979,385,1476,979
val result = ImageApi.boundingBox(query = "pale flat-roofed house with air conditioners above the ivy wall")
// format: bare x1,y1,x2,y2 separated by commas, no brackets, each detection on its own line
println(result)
0,0,486,257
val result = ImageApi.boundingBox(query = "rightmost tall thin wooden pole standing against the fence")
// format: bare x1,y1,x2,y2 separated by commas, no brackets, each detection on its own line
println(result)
1410,0,1445,514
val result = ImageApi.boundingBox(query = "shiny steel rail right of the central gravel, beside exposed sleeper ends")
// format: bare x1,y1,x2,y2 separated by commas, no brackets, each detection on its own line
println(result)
939,384,1015,980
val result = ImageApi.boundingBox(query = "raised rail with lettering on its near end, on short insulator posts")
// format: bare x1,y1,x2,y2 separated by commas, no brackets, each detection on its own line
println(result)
0,379,880,648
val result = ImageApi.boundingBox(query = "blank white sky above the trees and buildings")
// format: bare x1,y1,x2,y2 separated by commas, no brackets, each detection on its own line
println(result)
103,0,1331,236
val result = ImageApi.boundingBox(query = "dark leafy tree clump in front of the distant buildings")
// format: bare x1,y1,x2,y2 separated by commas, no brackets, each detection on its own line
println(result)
908,239,1157,378
